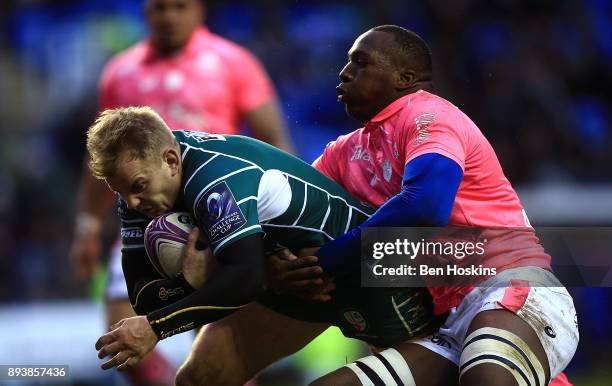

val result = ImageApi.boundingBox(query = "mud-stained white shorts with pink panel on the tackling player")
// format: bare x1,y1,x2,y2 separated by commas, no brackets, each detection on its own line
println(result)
414,267,578,379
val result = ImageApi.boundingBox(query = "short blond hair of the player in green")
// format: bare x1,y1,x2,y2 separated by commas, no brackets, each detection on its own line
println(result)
87,107,176,179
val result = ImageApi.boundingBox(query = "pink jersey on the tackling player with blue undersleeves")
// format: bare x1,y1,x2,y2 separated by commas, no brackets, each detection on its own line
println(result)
314,90,550,313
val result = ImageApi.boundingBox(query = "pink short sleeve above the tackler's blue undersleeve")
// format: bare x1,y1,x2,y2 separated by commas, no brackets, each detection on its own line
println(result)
403,111,466,169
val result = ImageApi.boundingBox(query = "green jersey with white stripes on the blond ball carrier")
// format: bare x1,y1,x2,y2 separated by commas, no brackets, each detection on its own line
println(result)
174,131,372,254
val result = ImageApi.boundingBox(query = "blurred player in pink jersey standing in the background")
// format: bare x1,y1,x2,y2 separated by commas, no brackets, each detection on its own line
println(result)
71,0,292,385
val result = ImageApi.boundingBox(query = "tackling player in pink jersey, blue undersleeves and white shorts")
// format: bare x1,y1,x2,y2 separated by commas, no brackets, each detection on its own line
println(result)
296,26,578,386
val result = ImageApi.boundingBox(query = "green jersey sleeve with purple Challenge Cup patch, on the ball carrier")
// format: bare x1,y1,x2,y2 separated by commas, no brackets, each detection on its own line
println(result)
185,154,263,255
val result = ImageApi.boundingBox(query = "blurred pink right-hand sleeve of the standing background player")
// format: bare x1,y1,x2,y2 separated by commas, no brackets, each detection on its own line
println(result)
234,48,276,114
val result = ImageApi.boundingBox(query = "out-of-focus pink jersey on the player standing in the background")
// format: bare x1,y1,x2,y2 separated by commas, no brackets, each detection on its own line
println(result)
100,27,275,134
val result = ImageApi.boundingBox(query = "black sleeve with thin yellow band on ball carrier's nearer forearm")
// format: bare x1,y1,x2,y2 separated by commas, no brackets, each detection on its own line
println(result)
147,233,264,339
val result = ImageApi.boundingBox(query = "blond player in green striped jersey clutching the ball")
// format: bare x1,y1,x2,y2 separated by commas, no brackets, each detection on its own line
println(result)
87,107,431,385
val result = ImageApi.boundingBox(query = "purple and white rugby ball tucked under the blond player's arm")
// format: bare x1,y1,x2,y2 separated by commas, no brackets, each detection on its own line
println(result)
144,212,195,279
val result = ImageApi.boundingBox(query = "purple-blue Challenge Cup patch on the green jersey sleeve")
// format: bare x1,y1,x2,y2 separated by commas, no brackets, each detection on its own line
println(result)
198,181,247,242
